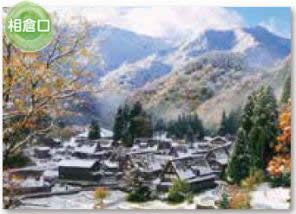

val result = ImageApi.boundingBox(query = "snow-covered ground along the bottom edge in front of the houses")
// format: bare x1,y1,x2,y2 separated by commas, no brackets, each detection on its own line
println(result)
18,186,222,209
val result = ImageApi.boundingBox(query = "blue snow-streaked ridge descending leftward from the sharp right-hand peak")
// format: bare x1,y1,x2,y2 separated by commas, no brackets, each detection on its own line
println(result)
101,26,291,91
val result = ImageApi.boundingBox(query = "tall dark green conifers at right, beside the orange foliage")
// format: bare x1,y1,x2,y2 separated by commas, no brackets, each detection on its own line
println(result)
227,87,278,183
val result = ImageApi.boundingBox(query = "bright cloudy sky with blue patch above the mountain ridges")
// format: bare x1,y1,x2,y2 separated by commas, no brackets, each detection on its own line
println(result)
54,6,290,38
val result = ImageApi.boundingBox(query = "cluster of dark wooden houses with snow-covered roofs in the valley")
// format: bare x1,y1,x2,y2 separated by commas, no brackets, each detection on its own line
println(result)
9,130,232,194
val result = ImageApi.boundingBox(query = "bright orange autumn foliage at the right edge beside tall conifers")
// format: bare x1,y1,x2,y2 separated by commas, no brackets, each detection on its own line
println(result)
267,102,292,176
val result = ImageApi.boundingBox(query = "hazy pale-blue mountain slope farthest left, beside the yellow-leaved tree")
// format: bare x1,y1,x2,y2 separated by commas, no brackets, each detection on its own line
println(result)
88,25,171,77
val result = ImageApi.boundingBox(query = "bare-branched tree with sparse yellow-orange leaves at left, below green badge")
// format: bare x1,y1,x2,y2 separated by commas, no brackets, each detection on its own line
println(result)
3,15,93,165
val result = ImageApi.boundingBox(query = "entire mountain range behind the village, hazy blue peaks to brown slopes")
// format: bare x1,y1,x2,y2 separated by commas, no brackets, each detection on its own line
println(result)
71,25,291,126
